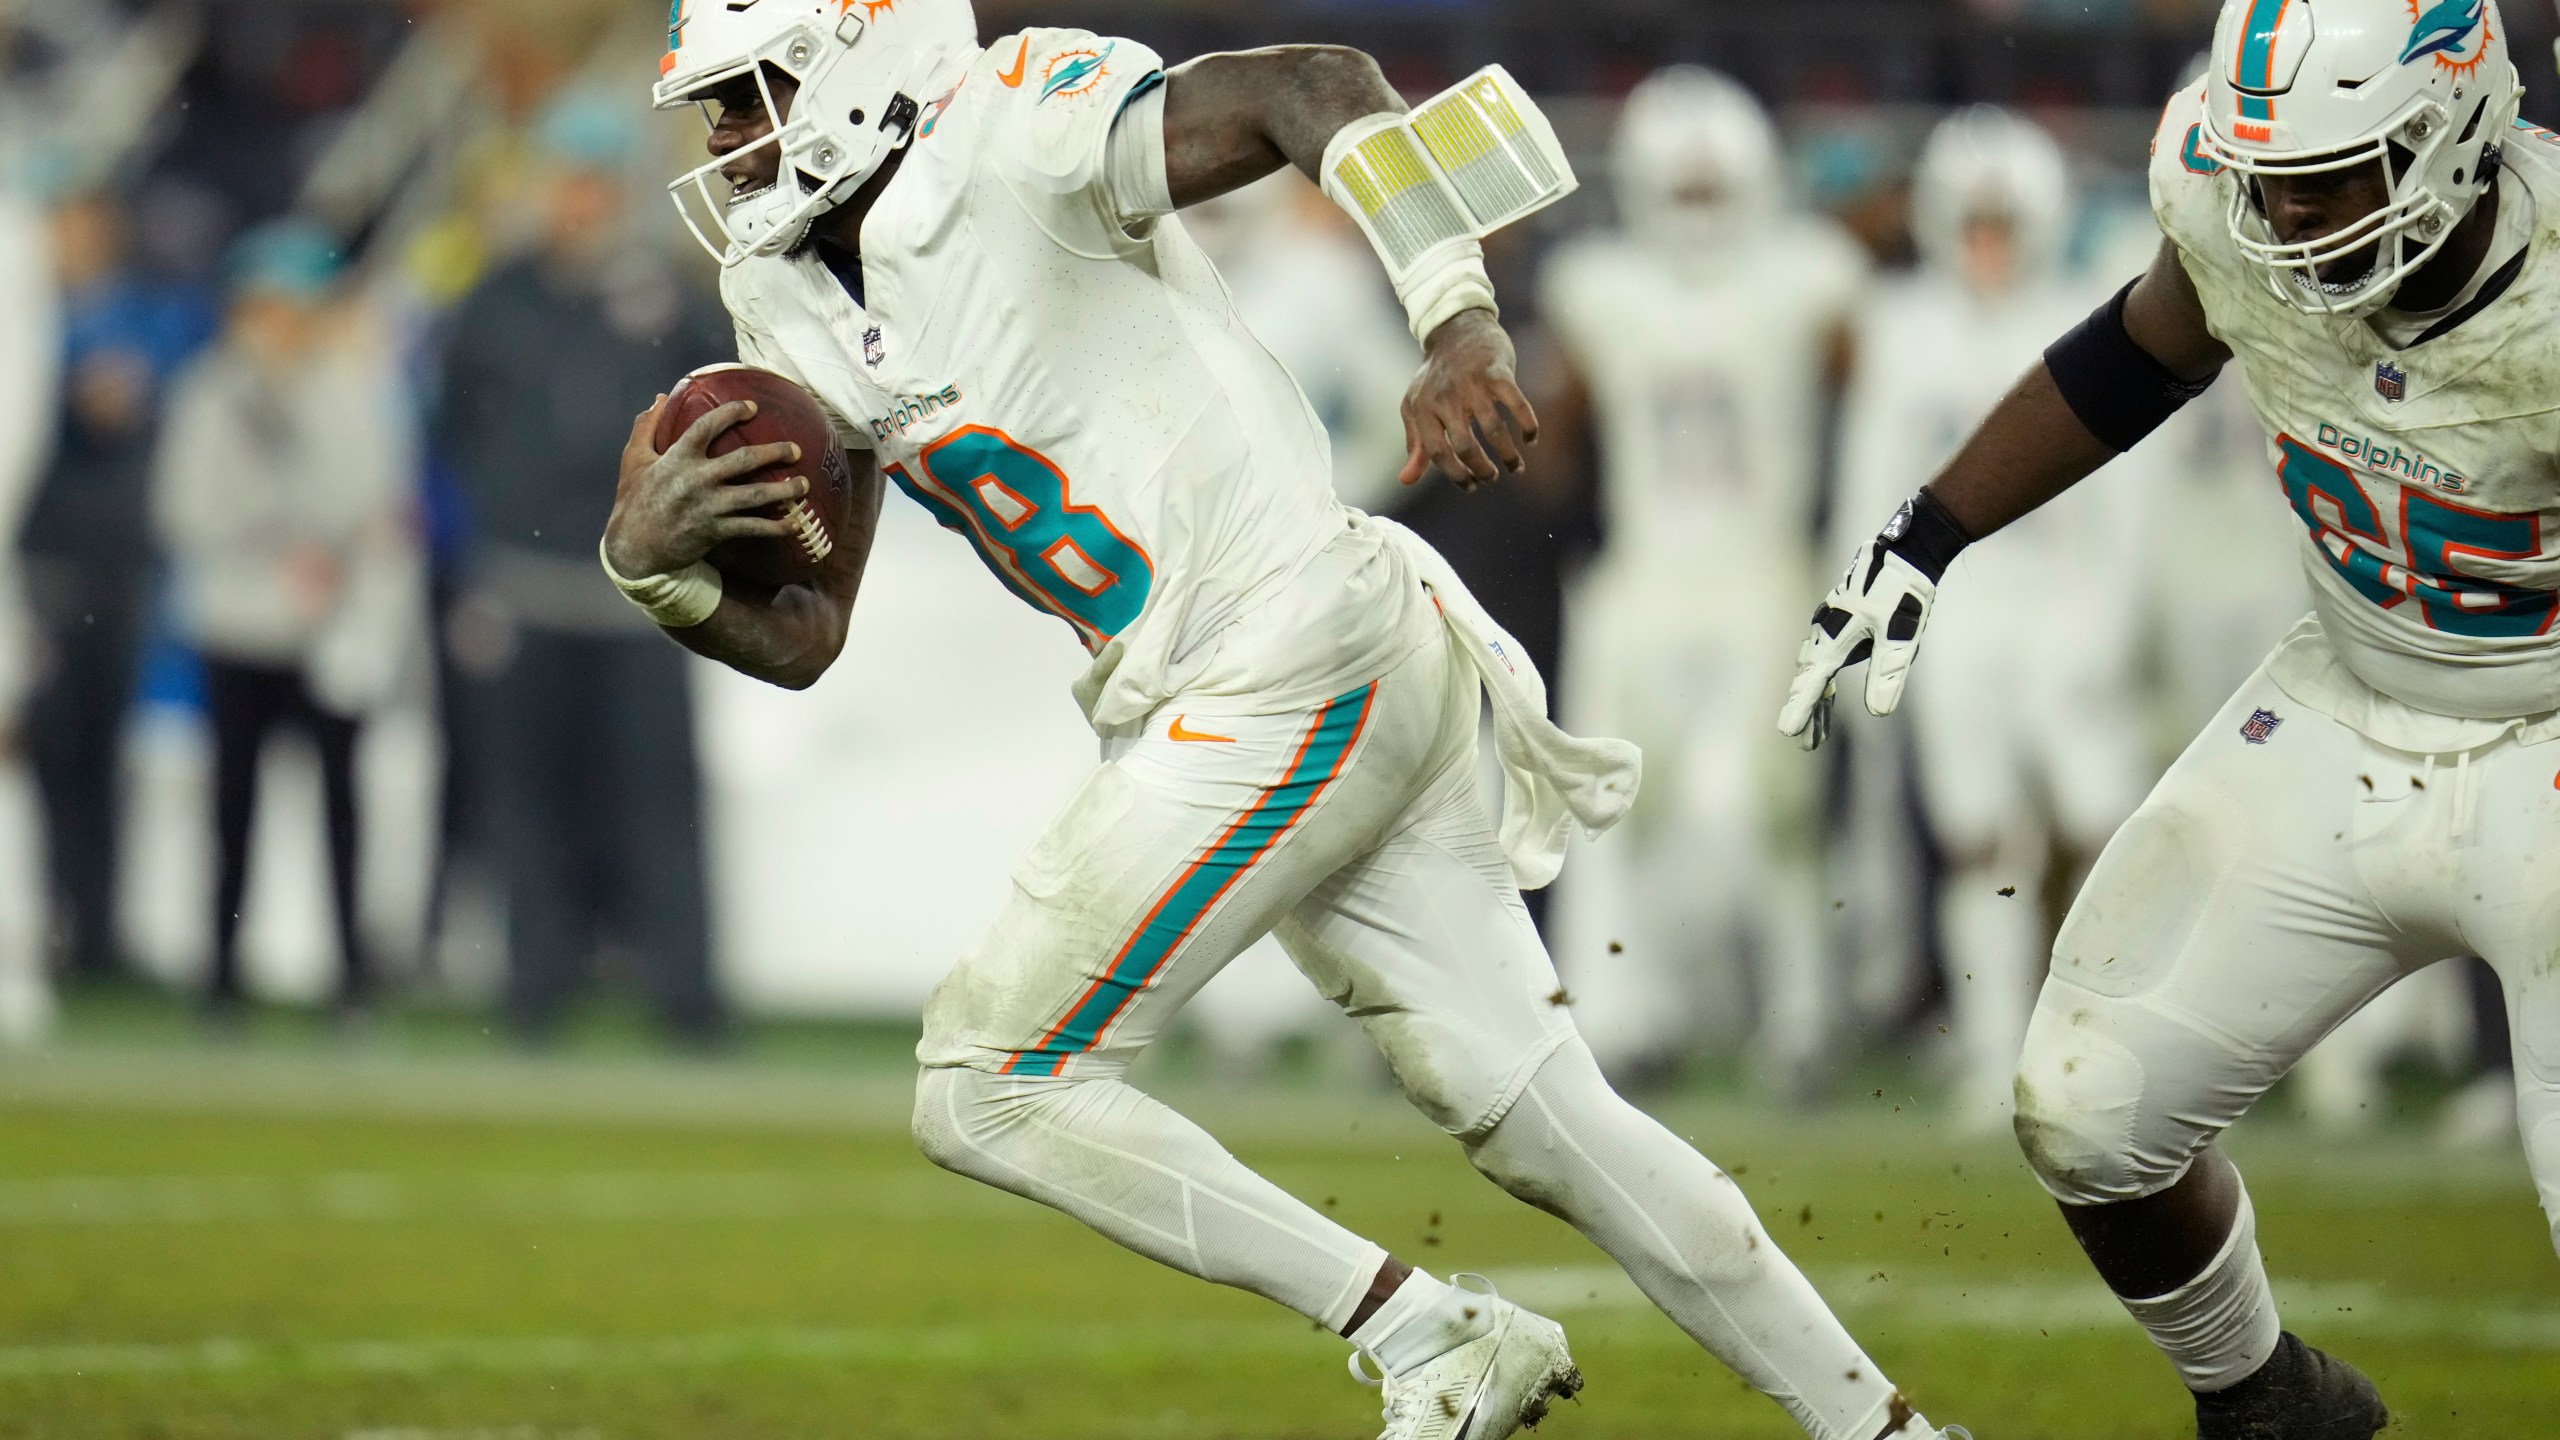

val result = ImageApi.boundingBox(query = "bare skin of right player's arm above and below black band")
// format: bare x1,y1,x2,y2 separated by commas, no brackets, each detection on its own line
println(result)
1928,241,2230,541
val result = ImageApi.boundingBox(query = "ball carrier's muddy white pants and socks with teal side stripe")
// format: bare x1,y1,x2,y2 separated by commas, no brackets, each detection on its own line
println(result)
916,627,1892,1440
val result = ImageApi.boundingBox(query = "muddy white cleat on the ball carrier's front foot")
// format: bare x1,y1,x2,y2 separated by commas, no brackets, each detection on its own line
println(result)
1352,1276,1582,1440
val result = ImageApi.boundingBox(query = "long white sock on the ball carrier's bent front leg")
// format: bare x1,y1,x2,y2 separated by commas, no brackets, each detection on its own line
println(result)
916,1068,1392,1332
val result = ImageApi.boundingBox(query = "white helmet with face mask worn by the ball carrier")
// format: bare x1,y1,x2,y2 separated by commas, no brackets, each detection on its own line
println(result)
655,0,978,266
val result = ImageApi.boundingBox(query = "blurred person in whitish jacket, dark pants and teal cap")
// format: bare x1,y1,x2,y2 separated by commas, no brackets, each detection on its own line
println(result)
154,220,420,1015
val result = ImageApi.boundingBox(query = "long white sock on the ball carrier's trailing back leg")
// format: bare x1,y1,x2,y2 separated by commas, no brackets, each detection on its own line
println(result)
1467,1040,1928,1440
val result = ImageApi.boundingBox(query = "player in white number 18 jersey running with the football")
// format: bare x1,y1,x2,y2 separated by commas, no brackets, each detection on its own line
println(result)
602,0,1938,1440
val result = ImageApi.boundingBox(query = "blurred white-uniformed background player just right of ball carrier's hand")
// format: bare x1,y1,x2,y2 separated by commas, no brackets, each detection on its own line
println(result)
1541,67,1866,1094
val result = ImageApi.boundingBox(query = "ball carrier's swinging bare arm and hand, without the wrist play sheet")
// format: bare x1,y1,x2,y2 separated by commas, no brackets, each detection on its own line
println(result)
1165,46,1539,489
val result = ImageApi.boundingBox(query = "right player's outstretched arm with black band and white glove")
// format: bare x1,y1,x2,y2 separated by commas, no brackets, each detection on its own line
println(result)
1777,241,2230,751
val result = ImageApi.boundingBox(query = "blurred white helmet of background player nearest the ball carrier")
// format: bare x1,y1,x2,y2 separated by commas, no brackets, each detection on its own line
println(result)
1610,64,1777,243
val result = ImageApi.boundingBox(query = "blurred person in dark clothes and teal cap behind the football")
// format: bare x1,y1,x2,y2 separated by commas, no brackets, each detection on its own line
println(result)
435,90,735,1043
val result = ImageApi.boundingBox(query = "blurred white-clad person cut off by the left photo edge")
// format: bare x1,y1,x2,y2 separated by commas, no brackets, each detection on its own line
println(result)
0,174,61,1045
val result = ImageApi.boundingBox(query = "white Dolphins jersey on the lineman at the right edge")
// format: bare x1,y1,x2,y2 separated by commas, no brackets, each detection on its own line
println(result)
2150,82,2560,722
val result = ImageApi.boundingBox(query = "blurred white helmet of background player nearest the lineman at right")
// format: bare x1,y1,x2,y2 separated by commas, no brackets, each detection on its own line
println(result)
1912,105,2071,277
